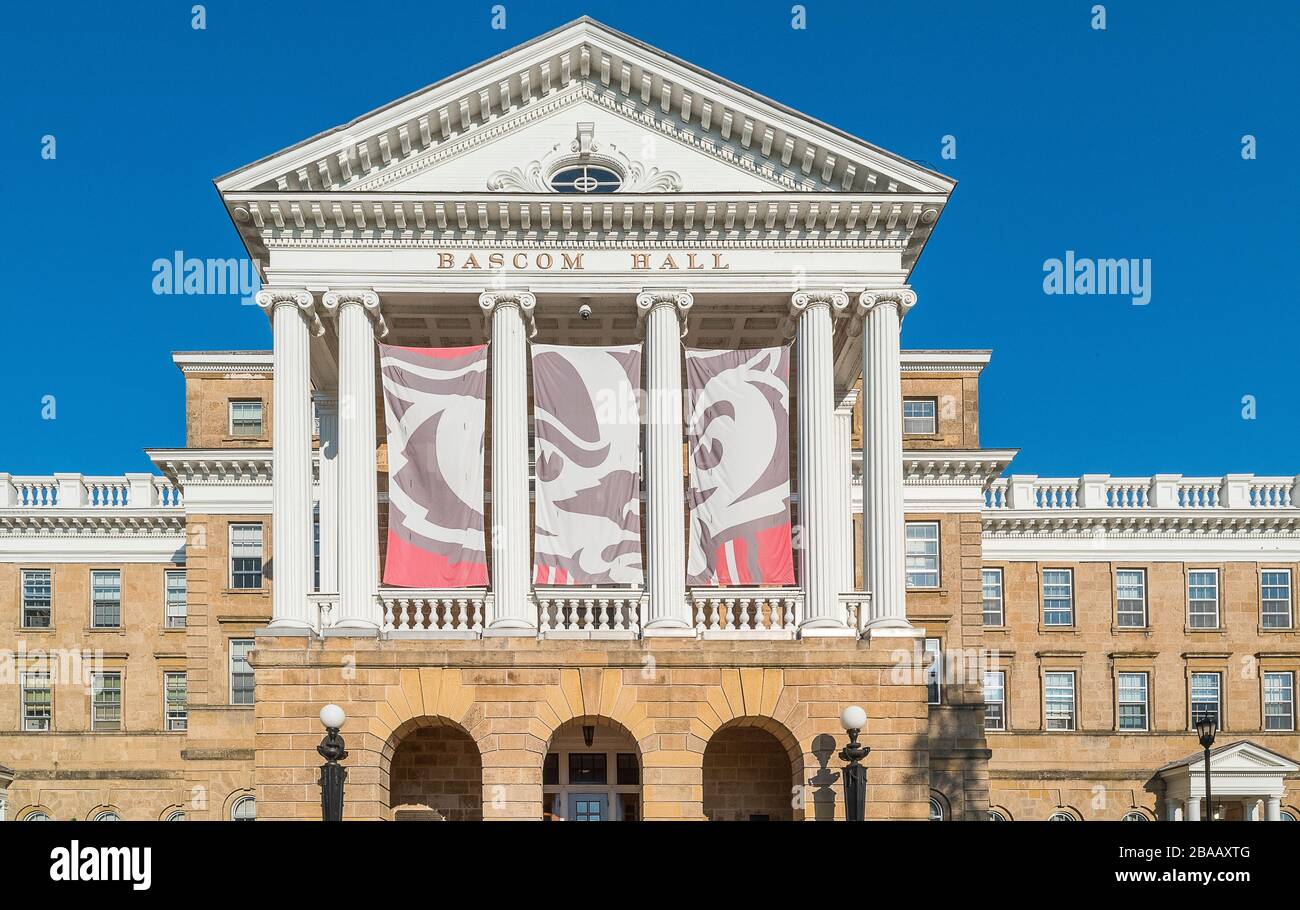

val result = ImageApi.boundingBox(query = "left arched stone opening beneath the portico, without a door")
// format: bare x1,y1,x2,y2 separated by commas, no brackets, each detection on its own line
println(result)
389,718,484,822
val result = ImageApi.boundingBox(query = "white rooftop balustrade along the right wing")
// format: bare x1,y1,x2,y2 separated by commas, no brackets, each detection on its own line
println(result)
984,475,1300,511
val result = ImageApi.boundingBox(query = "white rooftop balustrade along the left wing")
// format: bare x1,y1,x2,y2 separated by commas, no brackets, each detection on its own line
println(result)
0,473,182,511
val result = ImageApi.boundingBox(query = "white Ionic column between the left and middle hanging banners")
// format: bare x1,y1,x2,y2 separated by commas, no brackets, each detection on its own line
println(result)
478,290,537,636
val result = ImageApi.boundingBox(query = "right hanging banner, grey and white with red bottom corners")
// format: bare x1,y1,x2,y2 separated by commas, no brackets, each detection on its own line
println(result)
686,347,794,586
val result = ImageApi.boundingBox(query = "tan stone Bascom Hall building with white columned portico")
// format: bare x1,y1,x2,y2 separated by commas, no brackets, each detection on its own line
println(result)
0,20,1300,820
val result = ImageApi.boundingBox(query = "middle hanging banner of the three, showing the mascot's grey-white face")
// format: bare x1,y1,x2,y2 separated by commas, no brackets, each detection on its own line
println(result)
533,345,642,585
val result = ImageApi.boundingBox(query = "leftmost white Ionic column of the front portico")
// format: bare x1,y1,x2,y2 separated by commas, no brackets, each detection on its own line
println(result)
256,287,322,632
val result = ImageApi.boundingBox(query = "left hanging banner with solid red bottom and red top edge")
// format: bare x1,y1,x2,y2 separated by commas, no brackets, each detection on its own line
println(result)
384,345,488,588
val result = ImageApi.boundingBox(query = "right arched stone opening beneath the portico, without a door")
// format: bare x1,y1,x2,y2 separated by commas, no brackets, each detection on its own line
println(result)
703,722,803,822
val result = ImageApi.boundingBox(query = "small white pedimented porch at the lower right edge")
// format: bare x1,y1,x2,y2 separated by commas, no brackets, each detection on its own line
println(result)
1147,740,1300,822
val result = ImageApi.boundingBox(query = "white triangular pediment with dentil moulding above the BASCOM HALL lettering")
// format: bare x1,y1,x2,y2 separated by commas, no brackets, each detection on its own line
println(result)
217,20,954,195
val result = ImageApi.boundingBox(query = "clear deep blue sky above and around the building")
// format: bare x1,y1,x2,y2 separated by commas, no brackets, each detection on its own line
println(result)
0,0,1300,476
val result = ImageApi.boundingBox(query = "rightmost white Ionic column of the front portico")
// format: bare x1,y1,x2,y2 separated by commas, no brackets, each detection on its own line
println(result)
858,287,917,631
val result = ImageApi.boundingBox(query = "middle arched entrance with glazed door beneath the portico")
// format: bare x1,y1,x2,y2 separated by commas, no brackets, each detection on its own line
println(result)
542,718,641,822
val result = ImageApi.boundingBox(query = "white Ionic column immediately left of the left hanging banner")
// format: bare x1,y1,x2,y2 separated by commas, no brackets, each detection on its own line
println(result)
324,289,387,634
